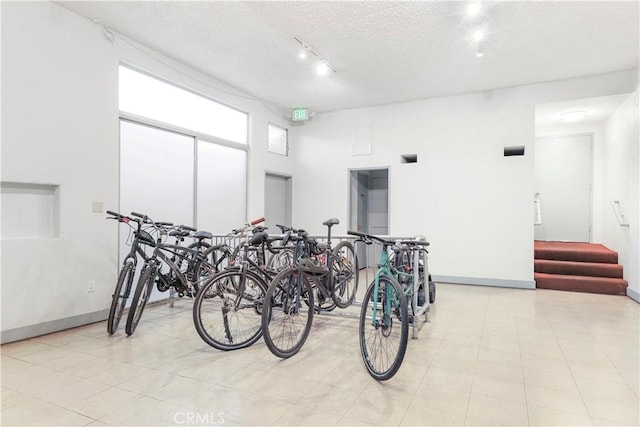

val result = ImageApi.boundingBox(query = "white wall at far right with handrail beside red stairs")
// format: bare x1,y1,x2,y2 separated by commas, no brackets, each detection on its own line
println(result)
602,90,640,300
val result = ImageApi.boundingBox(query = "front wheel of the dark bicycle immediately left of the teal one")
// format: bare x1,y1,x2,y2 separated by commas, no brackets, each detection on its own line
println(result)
262,267,314,359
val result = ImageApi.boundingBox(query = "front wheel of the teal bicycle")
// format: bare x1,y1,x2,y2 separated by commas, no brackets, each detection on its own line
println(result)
359,276,409,381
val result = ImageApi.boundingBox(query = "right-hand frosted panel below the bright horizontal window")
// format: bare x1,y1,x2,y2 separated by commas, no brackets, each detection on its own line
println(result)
197,141,247,234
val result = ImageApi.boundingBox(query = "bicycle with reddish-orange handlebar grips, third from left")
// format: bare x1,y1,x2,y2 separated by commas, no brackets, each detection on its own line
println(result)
193,218,286,351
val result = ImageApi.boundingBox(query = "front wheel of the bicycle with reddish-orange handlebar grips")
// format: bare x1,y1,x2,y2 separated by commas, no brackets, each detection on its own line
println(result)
193,269,267,350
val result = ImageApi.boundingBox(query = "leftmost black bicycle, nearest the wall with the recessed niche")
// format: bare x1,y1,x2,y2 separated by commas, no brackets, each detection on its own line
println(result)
107,210,168,335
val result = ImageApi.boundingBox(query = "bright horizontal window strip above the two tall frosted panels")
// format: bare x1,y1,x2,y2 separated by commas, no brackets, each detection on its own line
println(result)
119,66,249,144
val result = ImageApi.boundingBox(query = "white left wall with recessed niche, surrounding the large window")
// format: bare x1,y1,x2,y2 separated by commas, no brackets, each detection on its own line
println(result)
1,2,292,341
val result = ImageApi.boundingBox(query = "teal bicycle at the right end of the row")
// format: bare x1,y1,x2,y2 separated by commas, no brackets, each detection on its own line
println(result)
347,231,429,381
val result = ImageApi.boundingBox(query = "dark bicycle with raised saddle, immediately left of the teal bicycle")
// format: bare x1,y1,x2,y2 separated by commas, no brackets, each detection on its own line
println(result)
262,218,358,358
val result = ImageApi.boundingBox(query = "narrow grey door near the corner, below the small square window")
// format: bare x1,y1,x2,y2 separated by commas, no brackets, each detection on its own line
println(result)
264,173,291,233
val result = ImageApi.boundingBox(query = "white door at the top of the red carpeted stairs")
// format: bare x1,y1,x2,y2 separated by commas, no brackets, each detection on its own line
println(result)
535,135,592,242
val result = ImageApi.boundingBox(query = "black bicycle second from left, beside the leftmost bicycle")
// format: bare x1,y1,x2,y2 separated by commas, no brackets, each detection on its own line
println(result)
125,212,225,335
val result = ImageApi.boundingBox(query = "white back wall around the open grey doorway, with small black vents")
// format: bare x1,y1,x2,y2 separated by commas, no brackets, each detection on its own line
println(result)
292,70,636,287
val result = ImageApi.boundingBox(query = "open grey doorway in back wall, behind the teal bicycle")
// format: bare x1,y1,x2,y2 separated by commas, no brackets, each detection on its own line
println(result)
349,168,389,267
